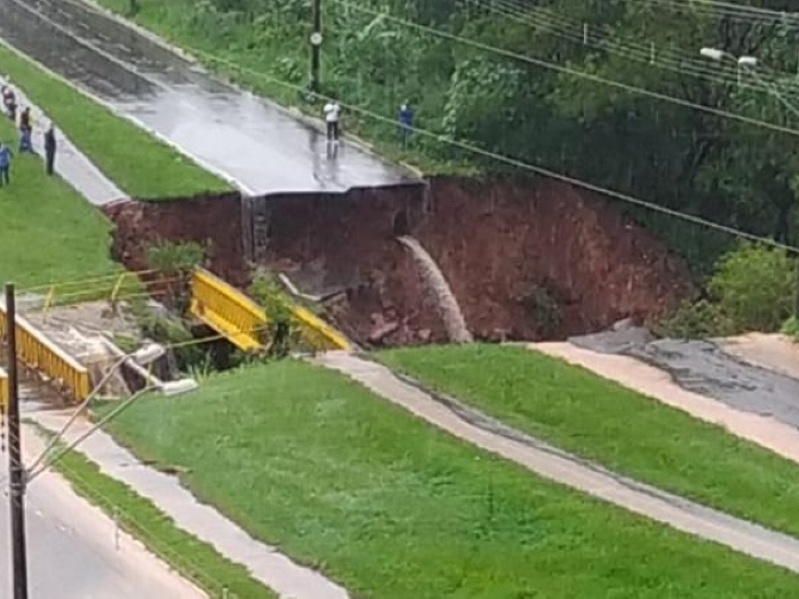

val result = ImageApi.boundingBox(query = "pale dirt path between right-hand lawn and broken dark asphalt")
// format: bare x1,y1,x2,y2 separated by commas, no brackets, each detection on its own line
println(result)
529,343,799,463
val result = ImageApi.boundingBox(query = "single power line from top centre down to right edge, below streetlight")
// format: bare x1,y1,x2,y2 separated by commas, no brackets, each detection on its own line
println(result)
332,0,799,135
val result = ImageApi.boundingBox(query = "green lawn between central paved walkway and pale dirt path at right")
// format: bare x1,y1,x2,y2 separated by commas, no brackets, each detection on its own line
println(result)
377,345,799,537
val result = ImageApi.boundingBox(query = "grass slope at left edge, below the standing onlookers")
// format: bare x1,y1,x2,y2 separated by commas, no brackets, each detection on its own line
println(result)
0,117,116,288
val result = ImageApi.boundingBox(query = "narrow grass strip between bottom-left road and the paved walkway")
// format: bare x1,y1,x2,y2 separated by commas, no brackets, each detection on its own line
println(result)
47,436,277,599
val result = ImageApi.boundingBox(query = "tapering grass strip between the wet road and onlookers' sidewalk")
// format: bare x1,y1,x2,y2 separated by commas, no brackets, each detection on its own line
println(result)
0,43,230,199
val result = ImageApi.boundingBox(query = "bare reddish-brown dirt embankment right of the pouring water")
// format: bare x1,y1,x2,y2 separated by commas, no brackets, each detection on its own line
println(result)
414,178,690,339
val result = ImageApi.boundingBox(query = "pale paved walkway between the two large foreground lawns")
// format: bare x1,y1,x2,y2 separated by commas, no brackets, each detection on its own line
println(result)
314,352,799,573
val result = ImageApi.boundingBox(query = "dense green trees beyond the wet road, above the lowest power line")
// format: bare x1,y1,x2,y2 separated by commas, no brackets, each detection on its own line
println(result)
114,0,799,265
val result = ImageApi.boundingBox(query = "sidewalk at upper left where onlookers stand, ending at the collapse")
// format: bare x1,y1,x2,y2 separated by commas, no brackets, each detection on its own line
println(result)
0,78,127,206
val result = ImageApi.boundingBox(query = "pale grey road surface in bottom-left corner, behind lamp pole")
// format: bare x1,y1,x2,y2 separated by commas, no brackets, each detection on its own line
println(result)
0,422,205,599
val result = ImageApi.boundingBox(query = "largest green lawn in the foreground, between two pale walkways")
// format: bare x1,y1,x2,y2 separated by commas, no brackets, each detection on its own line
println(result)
98,360,799,599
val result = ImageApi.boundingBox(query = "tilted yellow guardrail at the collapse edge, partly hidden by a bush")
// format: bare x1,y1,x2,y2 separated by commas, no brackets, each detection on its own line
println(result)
190,269,353,351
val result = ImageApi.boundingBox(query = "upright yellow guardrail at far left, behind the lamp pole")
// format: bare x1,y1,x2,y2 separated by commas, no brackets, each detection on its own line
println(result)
0,305,91,401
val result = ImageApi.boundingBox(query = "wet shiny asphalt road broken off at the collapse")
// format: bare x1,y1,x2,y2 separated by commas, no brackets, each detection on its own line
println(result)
0,0,414,194
